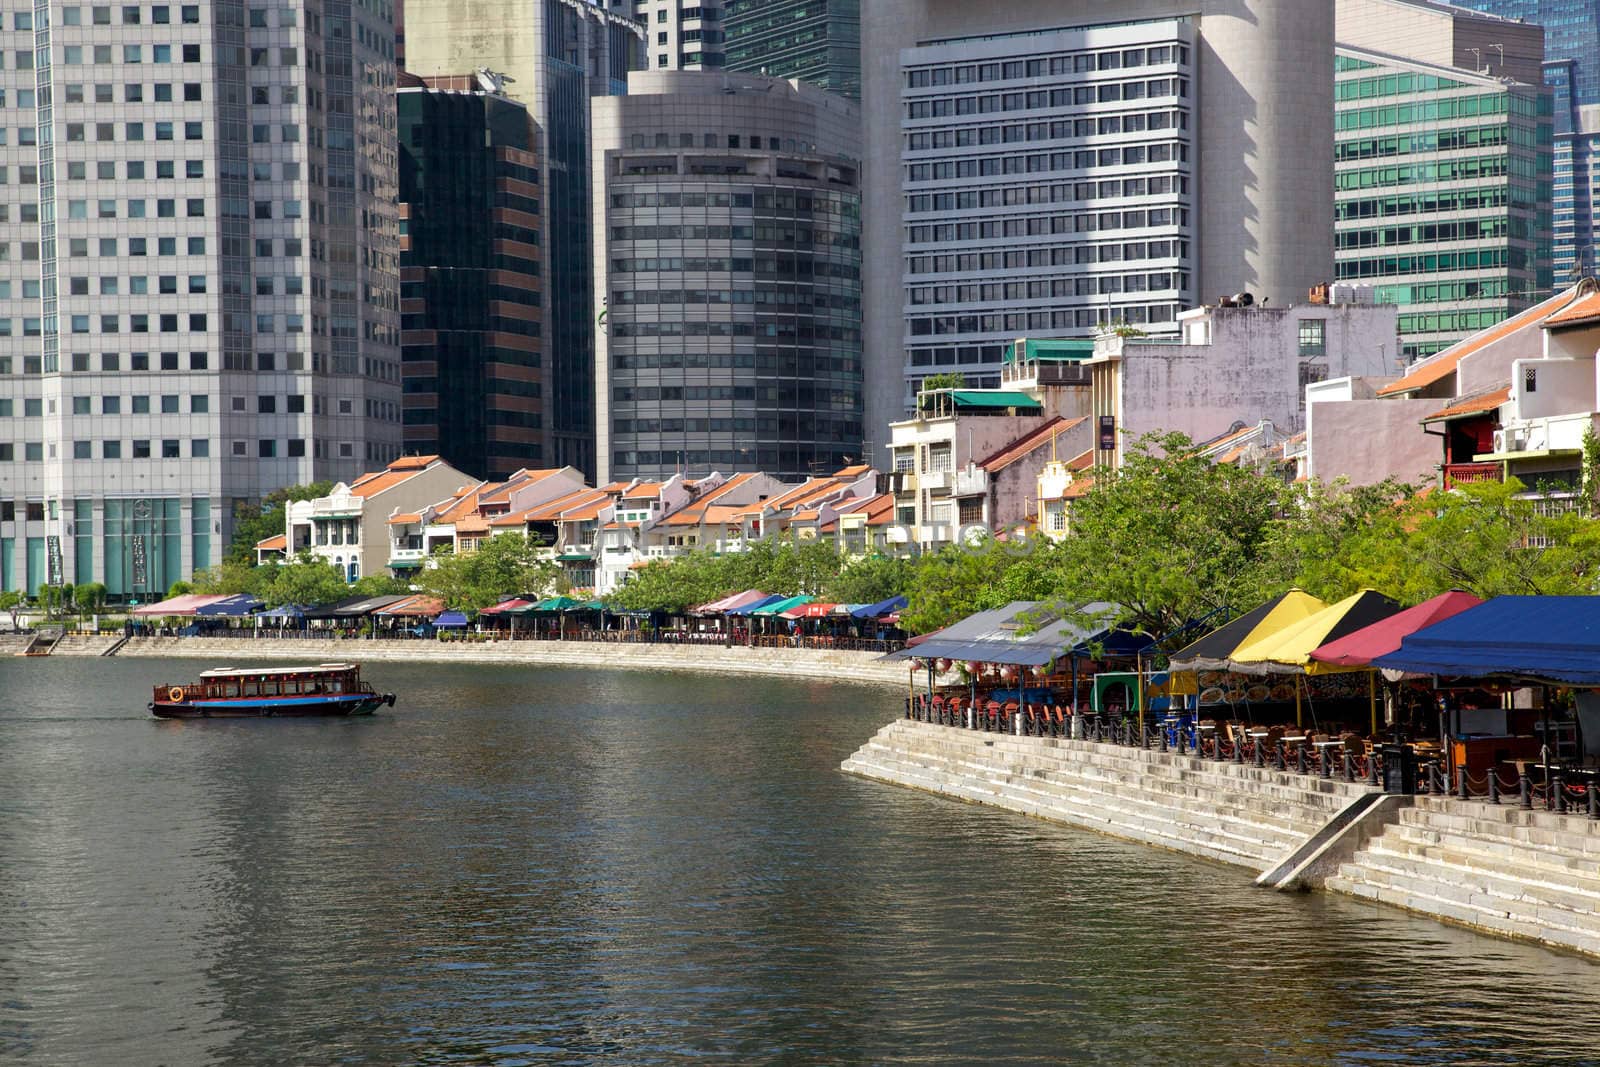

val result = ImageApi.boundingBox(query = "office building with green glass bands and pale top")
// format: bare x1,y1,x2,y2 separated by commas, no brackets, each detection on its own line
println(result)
1334,0,1550,362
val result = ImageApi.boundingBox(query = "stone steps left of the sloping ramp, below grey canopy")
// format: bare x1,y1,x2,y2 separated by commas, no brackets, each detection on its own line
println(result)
842,720,1368,872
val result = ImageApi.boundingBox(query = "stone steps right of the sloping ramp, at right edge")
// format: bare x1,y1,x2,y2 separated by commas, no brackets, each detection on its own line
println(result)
1326,797,1600,955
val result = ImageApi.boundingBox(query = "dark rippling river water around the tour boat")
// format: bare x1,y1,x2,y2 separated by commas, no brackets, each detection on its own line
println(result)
0,659,1600,1067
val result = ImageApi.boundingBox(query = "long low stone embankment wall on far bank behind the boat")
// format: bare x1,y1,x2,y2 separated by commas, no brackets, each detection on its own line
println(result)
117,637,906,691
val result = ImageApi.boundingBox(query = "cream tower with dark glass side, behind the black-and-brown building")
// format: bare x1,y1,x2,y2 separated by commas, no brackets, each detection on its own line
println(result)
405,0,645,474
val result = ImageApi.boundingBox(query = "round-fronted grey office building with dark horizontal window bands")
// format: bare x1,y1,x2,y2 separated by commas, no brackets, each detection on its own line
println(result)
592,72,862,482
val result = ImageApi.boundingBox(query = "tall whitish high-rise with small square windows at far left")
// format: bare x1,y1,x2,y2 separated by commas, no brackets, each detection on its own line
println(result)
0,0,400,600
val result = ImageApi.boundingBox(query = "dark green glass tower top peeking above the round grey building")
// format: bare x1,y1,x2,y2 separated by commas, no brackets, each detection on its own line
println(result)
723,0,861,98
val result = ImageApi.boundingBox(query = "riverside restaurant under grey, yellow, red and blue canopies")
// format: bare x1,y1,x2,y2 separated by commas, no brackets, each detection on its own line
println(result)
890,590,1600,817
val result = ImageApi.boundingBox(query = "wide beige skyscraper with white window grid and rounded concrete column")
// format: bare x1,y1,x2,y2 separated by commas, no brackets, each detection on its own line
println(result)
864,0,1333,451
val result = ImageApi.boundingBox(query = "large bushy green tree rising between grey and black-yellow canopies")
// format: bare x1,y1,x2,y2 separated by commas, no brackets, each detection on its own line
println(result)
1054,434,1290,635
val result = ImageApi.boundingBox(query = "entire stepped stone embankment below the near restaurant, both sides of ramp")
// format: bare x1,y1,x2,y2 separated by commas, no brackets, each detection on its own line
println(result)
842,720,1600,957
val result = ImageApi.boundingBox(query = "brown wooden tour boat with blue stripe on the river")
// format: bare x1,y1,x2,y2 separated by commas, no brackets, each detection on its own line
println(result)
150,664,395,718
